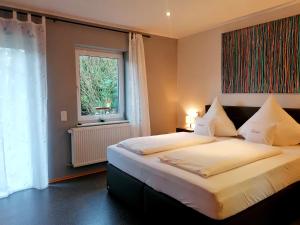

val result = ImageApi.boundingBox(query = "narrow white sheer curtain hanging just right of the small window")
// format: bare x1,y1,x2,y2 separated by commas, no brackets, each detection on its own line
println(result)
126,33,151,137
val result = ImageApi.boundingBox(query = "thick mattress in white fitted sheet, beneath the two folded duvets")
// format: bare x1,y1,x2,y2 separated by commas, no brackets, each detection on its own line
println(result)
107,140,300,220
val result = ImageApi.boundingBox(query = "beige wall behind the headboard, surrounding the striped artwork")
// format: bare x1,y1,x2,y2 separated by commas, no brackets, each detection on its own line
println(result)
178,4,300,126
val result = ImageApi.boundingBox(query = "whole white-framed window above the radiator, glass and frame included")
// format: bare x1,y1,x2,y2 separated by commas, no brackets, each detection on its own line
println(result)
75,49,124,121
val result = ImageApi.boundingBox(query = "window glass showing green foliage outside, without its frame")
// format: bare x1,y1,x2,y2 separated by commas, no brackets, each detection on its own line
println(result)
79,56,119,116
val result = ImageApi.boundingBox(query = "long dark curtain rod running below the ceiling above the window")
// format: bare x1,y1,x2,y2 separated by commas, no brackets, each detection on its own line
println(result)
0,5,151,38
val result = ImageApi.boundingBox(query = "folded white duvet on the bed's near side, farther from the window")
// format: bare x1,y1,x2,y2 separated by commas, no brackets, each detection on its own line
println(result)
159,139,281,177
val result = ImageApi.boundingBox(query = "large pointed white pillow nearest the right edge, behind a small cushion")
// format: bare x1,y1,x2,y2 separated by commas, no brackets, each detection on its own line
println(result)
238,96,300,146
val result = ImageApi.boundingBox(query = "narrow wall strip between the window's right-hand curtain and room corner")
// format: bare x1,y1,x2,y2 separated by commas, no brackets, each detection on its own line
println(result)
144,36,177,134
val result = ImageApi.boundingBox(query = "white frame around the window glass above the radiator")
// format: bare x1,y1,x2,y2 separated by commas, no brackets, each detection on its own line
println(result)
75,48,125,123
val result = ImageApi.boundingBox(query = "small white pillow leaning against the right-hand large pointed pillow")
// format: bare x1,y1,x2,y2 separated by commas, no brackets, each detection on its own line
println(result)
245,123,276,145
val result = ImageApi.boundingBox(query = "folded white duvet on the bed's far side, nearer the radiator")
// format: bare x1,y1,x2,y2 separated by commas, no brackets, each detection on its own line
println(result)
117,132,215,155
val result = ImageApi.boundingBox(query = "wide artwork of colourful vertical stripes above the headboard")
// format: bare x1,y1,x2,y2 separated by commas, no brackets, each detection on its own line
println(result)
222,15,300,93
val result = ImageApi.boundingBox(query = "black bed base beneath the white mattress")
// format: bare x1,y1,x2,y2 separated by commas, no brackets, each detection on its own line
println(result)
107,164,300,225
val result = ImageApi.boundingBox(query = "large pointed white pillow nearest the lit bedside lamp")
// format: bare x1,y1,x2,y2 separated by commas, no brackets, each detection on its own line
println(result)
203,98,237,137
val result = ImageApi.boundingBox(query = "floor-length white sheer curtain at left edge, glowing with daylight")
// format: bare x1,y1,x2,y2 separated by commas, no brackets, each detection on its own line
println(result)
0,12,48,198
